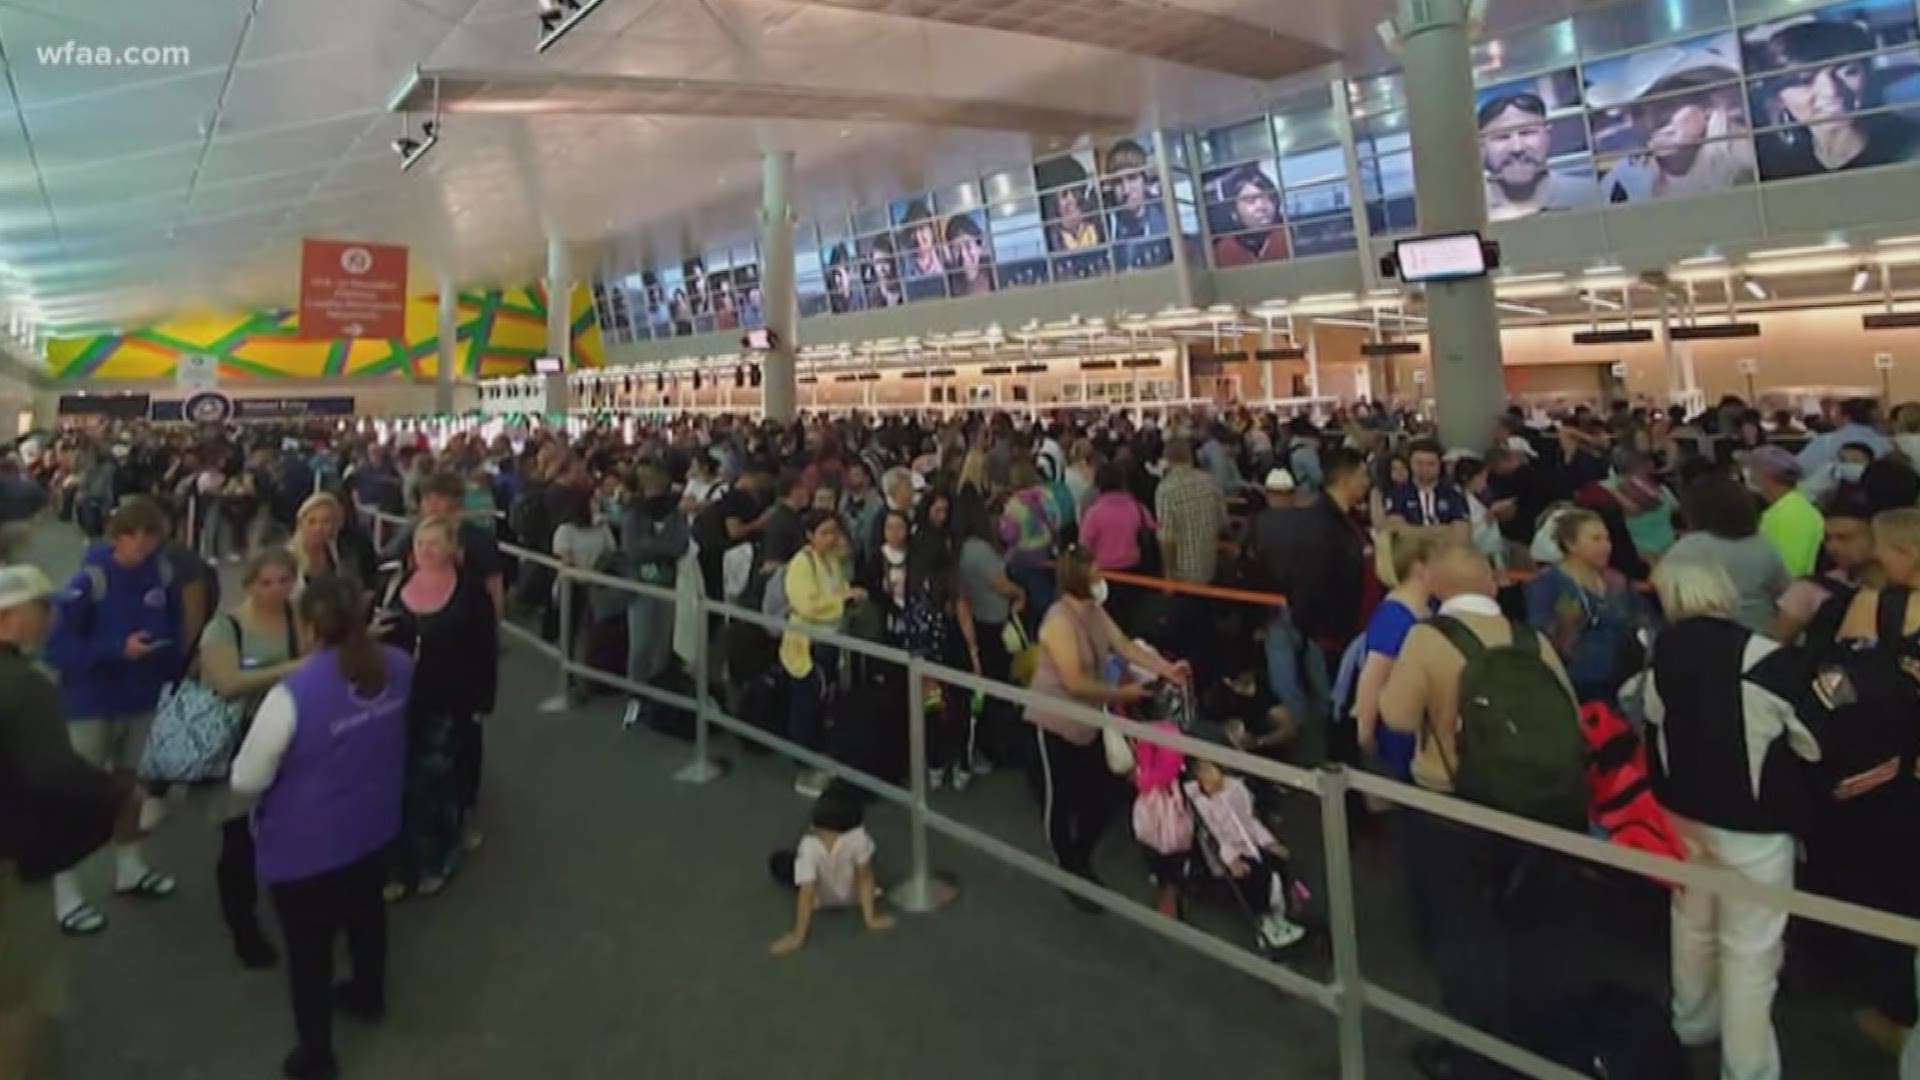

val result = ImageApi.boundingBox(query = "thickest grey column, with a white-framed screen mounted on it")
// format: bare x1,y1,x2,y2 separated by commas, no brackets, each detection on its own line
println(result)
1396,0,1507,450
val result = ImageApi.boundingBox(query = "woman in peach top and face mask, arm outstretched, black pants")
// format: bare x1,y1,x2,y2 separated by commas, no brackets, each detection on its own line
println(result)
1027,548,1192,911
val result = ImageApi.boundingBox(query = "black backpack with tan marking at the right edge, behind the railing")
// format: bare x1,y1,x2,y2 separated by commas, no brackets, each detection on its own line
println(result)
1812,588,1920,801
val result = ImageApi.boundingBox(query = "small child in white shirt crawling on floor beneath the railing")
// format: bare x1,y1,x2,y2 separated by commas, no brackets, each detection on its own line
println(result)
766,784,893,957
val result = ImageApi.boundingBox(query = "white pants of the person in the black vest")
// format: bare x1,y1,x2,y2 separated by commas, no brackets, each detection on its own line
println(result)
1672,815,1793,1080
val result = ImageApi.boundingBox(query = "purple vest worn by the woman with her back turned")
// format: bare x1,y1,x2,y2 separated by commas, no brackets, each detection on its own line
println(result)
253,648,413,882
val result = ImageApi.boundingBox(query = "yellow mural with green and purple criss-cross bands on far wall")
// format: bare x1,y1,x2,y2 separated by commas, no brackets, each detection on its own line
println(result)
46,284,607,382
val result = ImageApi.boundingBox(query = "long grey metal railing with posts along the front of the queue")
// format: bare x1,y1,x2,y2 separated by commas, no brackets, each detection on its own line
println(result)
360,515,1920,1080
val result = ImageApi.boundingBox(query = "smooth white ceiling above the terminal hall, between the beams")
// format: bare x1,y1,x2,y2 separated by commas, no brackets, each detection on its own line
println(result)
0,0,1574,332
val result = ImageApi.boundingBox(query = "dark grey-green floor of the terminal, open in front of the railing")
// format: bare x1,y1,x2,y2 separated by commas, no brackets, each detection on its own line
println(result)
22,518,1893,1080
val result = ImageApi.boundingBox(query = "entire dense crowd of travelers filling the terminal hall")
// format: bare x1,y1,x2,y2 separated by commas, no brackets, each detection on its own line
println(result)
11,390,1920,1080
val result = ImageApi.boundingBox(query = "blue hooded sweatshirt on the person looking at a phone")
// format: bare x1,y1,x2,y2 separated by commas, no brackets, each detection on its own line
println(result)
46,544,184,721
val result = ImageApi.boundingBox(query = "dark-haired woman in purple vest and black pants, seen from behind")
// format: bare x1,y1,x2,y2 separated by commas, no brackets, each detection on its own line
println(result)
232,575,413,1080
